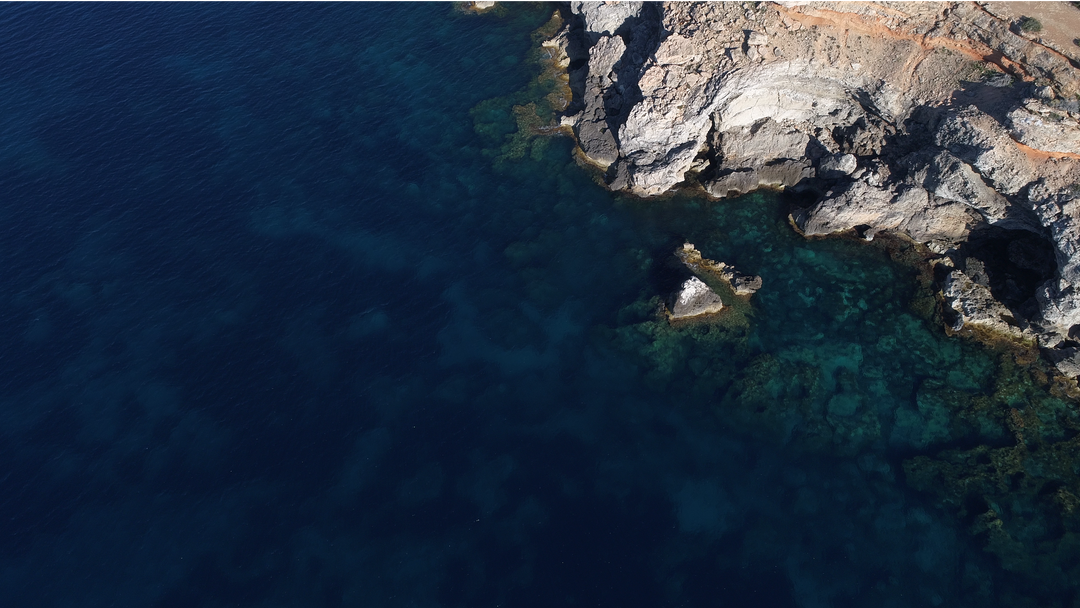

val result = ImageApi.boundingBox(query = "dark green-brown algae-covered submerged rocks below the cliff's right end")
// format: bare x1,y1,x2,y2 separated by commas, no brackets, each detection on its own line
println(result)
904,352,1080,586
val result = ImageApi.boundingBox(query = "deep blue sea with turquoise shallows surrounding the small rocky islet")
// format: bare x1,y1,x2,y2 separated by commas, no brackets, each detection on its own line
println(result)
0,3,1067,607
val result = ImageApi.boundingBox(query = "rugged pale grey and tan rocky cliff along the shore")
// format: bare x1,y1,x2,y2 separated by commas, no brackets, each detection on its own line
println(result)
555,2,1080,375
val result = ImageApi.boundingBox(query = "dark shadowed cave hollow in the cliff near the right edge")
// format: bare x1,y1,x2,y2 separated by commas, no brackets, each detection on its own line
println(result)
960,226,1057,319
